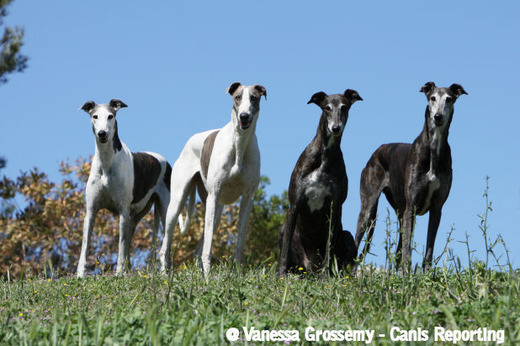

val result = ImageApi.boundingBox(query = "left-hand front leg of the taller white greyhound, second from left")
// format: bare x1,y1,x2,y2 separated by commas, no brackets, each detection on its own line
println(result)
200,193,224,275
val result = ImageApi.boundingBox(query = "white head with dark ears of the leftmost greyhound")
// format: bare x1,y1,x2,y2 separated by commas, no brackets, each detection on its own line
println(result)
80,99,128,144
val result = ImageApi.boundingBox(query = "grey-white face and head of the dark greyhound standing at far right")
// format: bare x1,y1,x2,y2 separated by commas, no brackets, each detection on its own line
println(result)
420,82,468,130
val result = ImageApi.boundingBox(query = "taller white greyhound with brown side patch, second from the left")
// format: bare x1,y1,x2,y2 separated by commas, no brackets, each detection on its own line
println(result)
159,82,267,274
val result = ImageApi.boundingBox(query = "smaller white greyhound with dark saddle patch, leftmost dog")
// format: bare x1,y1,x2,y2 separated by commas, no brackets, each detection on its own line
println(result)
78,99,174,277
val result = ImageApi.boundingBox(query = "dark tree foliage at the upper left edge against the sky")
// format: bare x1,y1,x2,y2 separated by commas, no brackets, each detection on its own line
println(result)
0,0,28,85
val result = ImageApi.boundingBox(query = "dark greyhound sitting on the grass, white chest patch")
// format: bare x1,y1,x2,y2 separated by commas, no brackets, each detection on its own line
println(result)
278,89,362,275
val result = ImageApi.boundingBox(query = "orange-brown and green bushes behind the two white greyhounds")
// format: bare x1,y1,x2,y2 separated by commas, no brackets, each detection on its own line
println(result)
0,158,288,276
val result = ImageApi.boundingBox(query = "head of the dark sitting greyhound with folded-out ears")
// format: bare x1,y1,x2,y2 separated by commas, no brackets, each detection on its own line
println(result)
307,89,363,137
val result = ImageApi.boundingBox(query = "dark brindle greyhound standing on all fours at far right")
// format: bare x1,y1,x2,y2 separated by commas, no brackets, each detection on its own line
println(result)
356,82,467,270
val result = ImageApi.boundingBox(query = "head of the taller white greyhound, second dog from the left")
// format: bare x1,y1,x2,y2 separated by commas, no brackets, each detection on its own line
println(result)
226,82,267,131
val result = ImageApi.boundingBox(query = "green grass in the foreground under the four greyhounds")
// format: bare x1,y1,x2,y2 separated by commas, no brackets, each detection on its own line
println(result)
0,260,520,345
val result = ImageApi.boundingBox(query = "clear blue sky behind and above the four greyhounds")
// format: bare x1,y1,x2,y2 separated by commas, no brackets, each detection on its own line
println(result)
0,0,520,266
